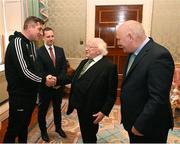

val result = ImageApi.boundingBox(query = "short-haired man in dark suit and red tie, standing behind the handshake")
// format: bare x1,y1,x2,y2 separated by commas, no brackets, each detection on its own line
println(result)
37,27,67,142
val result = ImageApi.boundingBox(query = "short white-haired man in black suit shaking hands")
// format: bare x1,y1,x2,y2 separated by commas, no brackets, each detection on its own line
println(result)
67,38,118,143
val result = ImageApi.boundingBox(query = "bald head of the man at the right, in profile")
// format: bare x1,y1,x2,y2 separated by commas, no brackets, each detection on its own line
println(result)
116,20,146,53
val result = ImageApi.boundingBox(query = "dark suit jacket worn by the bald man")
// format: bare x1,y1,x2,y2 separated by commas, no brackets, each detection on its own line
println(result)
120,38,174,135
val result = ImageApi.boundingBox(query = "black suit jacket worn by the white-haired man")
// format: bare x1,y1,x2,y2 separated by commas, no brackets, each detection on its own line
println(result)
67,57,118,116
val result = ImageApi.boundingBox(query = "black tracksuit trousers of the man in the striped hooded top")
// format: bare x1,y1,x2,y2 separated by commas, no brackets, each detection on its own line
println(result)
4,94,37,143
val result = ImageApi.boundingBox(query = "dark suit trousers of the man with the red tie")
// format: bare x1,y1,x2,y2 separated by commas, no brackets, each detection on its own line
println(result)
38,90,63,133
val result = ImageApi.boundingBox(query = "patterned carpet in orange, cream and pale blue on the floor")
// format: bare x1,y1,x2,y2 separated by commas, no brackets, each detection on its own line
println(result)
28,100,180,143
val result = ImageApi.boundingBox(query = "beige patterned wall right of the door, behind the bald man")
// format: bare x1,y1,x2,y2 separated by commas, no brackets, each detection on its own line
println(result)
151,0,180,63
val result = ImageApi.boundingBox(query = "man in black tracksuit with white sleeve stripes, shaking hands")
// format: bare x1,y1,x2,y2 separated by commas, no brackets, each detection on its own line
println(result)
4,16,56,143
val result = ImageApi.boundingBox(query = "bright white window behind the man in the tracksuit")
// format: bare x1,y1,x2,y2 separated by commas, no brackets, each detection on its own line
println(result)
0,0,24,71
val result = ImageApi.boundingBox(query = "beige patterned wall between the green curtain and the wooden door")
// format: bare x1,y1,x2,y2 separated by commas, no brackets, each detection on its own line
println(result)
47,0,86,58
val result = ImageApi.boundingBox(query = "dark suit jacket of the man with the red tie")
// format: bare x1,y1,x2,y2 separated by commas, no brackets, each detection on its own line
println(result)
37,46,67,92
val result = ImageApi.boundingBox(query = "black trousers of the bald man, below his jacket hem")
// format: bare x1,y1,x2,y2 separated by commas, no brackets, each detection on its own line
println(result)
128,130,169,143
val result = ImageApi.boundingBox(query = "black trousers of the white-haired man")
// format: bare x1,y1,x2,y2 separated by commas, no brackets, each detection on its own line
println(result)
77,108,99,143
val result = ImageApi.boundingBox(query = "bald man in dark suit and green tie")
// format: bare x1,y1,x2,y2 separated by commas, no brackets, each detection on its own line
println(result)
117,20,174,143
